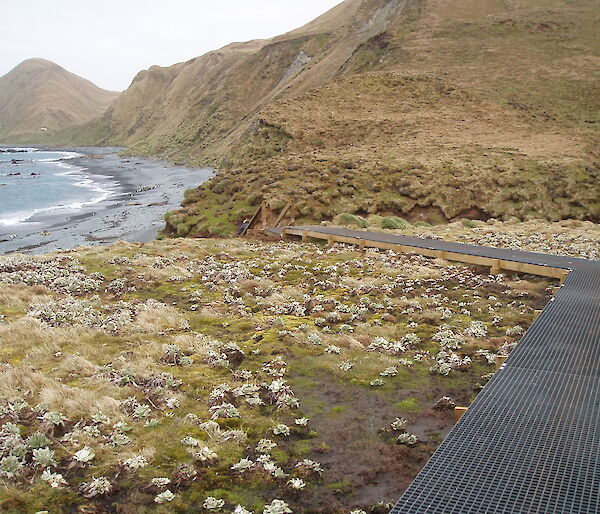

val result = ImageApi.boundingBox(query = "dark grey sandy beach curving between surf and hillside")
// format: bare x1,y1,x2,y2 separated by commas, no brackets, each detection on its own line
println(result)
0,148,214,254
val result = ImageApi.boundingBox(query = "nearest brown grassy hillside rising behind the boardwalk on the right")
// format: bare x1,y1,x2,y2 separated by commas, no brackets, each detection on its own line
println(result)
162,1,600,234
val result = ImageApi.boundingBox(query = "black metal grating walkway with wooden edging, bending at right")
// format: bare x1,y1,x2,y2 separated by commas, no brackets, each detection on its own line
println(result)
273,226,600,514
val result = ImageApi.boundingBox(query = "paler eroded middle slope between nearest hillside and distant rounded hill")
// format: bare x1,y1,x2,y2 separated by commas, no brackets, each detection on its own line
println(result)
78,0,406,159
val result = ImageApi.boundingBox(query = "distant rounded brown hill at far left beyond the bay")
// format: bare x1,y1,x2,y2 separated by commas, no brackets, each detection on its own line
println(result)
0,59,118,143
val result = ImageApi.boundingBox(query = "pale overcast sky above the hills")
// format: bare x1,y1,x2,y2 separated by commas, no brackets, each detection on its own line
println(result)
0,0,341,91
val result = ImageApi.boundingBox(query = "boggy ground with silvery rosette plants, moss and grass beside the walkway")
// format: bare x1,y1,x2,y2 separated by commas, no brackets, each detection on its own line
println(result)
0,239,555,513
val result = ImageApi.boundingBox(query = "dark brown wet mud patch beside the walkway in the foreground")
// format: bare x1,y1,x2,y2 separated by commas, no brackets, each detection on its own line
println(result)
290,372,460,512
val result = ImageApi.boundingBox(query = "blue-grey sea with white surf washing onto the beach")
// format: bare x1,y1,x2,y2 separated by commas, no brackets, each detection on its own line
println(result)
0,148,116,229
